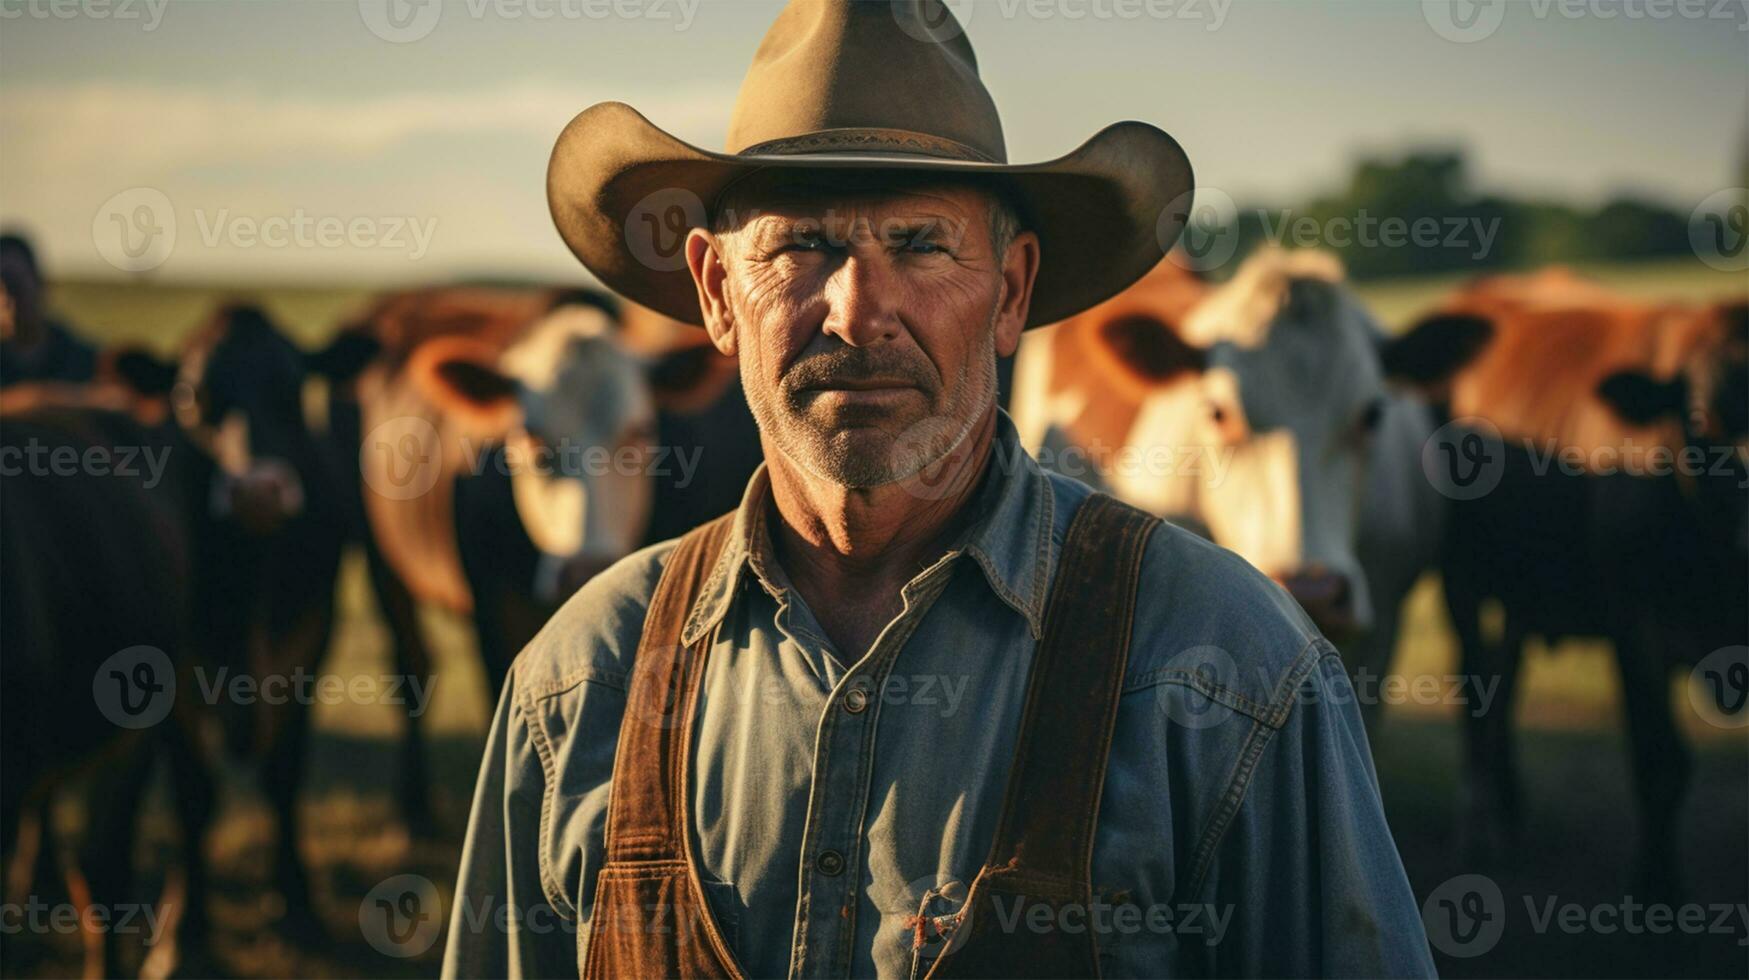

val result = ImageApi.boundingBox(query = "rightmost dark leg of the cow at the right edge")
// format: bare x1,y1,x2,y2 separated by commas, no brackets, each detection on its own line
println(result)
1614,630,1691,898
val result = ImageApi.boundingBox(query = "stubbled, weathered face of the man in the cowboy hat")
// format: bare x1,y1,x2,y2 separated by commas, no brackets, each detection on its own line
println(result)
694,186,1035,488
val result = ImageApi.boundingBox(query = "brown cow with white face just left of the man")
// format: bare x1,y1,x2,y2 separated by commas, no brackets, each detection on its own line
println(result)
336,287,761,831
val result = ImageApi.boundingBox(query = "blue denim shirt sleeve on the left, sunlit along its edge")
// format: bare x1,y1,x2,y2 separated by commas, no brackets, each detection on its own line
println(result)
442,670,577,978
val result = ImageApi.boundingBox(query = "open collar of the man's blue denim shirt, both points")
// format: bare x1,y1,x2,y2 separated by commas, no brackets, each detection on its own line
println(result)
680,410,1056,646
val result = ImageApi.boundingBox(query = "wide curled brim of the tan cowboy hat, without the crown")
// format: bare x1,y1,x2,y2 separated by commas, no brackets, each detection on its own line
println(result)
547,102,1195,327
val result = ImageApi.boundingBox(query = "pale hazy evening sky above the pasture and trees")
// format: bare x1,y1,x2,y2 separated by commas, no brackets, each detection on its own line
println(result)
0,0,1749,284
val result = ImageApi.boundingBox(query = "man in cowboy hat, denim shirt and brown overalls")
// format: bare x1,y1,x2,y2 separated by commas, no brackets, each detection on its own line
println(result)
444,2,1431,977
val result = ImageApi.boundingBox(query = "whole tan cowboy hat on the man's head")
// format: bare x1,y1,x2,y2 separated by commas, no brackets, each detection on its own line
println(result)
547,0,1193,327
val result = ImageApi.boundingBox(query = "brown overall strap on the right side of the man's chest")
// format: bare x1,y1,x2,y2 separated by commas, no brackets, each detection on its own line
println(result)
929,494,1160,977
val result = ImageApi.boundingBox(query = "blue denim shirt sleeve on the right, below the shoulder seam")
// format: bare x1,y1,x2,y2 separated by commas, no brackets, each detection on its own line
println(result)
1198,651,1434,977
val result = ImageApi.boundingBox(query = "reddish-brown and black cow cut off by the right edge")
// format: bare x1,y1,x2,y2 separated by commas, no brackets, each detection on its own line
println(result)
1413,270,1749,894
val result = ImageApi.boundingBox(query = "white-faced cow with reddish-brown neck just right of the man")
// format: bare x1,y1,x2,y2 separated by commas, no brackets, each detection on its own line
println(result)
1014,249,1487,723
